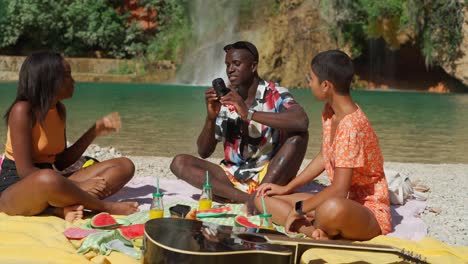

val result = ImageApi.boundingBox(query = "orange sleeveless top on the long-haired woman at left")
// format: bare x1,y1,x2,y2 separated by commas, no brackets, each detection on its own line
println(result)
5,108,65,163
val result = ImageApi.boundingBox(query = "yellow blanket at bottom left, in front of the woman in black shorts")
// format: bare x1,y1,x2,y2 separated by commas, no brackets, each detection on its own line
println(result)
0,213,139,264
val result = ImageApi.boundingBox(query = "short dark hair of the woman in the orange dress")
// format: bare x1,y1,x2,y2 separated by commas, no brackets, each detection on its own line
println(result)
310,50,354,95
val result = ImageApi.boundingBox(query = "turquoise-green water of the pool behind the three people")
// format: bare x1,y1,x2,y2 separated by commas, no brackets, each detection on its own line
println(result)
0,83,468,163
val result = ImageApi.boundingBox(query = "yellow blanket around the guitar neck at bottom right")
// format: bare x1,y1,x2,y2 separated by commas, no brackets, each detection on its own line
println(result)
301,236,468,264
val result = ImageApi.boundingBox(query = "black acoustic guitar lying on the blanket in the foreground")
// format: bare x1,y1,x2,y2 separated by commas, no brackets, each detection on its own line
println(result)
142,218,427,264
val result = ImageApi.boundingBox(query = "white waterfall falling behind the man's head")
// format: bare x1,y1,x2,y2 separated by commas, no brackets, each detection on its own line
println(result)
176,0,241,85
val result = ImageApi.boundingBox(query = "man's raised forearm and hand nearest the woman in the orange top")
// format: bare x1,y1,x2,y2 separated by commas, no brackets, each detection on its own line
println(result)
197,87,221,159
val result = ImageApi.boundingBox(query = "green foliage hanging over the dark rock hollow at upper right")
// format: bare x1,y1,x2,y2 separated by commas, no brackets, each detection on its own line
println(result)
321,0,463,65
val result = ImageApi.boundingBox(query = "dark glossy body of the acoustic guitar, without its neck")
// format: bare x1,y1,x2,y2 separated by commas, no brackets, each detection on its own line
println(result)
142,218,294,264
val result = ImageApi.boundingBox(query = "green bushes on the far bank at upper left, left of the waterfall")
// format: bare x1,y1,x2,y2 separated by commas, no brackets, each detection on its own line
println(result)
0,0,150,58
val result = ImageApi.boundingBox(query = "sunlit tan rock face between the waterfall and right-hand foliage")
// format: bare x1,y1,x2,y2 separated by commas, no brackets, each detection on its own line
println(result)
241,0,337,88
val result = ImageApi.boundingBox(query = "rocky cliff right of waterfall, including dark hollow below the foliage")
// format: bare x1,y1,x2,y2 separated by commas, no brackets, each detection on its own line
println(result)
239,0,468,92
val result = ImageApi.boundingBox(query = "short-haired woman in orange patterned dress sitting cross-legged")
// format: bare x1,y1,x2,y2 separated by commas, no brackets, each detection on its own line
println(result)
255,50,392,240
